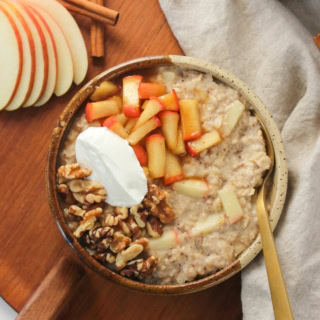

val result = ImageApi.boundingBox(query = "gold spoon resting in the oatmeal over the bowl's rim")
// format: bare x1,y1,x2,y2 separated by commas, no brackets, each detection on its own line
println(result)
254,112,293,320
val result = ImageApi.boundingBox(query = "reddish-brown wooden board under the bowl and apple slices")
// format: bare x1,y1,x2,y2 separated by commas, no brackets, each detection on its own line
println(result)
0,0,242,320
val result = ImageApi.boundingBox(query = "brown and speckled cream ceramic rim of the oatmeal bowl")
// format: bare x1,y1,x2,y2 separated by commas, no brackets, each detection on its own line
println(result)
46,56,288,294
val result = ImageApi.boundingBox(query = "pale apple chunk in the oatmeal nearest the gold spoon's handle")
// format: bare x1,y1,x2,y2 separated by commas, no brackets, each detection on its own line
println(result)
218,188,243,224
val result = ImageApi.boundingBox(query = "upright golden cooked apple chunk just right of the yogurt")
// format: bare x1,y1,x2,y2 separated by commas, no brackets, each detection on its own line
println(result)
145,132,166,178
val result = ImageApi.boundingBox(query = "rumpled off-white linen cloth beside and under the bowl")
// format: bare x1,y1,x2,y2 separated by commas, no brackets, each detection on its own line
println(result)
160,0,320,320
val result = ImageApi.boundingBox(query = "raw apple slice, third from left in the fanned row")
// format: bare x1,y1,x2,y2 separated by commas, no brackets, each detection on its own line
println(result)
5,0,49,107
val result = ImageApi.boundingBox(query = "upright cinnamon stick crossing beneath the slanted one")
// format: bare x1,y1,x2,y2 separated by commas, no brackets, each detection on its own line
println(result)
90,0,104,58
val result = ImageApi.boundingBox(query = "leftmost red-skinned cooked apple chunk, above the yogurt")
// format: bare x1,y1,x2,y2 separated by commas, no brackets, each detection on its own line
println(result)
85,99,120,122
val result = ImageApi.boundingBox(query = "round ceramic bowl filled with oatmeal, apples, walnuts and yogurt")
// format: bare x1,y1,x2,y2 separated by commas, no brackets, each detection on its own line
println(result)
46,56,287,294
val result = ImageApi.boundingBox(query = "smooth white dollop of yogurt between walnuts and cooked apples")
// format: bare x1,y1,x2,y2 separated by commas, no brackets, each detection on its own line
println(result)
75,127,148,207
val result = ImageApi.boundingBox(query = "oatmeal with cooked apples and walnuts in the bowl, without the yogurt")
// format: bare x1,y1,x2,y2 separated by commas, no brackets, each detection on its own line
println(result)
58,67,270,284
